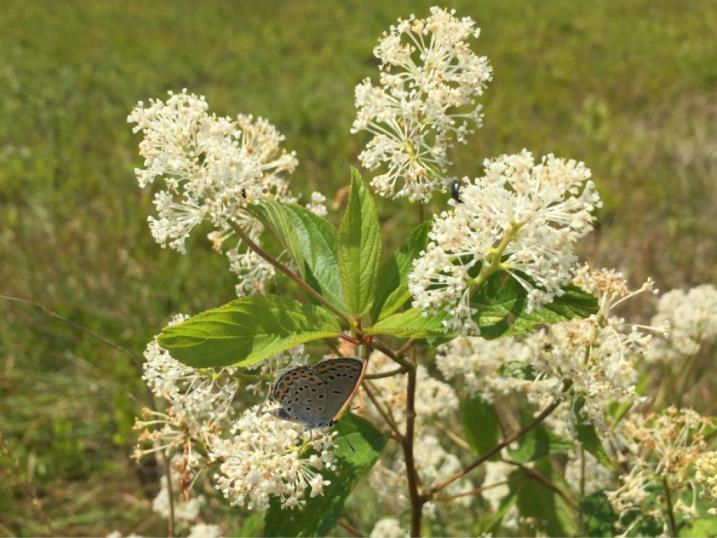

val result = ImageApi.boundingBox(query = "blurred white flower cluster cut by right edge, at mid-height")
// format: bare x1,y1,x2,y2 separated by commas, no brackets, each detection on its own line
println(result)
647,284,717,362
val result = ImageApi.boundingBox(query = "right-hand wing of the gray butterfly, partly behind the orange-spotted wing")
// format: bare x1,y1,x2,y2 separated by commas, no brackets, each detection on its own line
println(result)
313,357,364,426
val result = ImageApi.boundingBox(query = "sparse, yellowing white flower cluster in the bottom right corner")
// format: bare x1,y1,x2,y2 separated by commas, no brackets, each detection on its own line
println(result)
606,407,709,524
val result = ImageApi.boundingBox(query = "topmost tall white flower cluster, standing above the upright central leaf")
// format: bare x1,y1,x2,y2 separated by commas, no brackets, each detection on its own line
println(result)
351,7,491,202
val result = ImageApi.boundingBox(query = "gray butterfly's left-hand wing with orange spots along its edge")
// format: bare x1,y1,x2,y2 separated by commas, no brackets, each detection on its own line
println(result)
272,366,328,428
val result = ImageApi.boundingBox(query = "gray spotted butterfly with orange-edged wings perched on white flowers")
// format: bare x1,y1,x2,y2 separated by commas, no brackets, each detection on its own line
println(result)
271,357,367,428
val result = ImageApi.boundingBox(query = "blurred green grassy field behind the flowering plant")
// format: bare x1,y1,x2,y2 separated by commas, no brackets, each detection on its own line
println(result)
0,0,717,535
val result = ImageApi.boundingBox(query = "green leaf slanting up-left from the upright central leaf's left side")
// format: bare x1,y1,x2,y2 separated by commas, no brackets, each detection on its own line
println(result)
249,201,347,312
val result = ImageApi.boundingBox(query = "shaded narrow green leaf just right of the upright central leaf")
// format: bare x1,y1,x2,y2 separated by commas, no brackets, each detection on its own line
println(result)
371,222,431,319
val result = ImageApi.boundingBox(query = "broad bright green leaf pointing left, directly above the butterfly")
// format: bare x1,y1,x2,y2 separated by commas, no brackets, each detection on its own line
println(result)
159,295,341,368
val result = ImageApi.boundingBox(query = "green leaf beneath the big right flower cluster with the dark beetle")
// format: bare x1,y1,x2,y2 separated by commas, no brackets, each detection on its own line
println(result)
471,273,597,339
